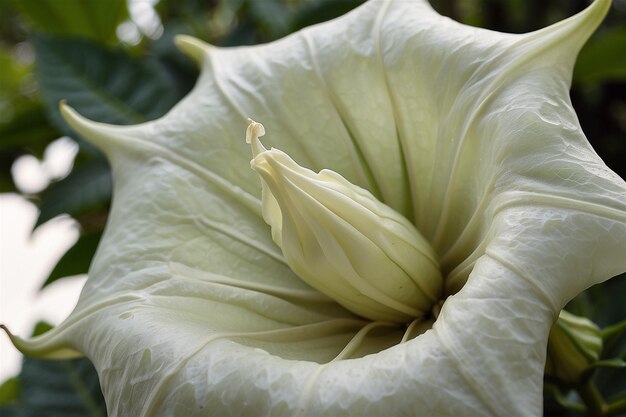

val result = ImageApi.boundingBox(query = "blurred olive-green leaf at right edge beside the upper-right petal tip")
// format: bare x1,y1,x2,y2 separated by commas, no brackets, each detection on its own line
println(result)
574,26,626,85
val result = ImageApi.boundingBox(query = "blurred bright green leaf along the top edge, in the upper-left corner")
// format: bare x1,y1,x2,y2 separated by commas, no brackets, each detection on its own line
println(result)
7,0,128,42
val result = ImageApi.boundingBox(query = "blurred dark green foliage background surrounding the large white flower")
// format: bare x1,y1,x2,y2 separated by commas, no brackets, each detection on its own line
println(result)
0,0,626,417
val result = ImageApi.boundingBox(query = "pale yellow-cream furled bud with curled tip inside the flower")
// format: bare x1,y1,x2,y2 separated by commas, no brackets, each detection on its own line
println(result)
246,120,443,328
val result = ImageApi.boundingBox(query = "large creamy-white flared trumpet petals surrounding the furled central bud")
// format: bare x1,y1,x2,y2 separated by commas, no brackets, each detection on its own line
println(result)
4,0,626,417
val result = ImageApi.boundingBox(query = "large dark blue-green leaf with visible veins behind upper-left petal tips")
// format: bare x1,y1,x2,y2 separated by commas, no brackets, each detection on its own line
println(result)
33,36,180,132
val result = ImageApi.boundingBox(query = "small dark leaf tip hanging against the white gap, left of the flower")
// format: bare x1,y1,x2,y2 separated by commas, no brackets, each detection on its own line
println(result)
42,231,102,288
